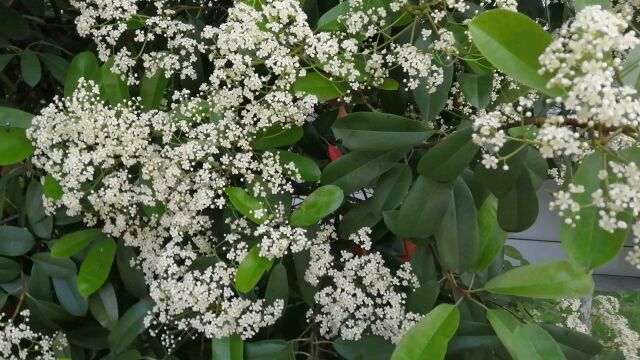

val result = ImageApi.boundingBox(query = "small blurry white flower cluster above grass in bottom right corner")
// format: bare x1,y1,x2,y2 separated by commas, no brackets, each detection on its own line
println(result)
559,295,640,360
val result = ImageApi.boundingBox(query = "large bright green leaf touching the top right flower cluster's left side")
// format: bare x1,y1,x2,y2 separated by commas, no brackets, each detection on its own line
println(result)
469,9,563,97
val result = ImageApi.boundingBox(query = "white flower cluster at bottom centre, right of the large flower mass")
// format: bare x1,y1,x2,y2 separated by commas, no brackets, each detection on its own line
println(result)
306,240,422,343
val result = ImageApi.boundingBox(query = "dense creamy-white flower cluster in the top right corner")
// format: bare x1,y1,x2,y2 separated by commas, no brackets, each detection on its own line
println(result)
540,5,640,129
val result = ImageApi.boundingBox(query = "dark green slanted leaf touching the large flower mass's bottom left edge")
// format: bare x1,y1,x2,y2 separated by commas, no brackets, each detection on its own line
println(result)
107,299,153,352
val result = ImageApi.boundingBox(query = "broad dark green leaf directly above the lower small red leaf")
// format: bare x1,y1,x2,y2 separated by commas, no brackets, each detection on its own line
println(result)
392,176,454,239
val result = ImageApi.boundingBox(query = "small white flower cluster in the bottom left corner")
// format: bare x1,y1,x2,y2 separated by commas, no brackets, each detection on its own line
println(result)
0,310,56,360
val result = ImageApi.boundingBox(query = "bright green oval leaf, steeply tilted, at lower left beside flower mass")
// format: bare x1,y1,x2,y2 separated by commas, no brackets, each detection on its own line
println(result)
77,239,116,297
